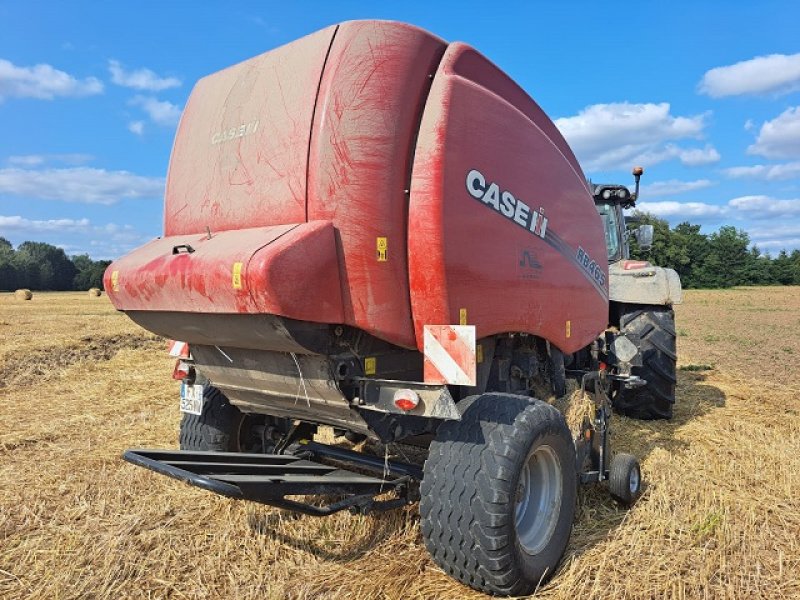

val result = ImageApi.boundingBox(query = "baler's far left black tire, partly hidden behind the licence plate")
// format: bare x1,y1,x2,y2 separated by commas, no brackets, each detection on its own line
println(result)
180,386,245,452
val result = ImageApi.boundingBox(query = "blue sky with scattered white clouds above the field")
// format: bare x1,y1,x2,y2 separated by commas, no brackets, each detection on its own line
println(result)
0,0,800,258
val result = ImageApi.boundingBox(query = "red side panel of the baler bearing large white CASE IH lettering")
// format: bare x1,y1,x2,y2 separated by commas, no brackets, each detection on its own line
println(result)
409,44,608,352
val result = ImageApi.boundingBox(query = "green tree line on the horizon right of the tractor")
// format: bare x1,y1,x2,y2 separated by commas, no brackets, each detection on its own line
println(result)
631,213,800,288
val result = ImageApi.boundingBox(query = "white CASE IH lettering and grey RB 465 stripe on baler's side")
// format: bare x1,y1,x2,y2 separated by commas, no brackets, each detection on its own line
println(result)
466,169,608,299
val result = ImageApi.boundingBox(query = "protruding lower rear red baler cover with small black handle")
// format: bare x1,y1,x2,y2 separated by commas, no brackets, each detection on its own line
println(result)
105,221,343,323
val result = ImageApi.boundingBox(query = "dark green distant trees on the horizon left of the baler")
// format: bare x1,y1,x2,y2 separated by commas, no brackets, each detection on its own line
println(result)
0,237,111,291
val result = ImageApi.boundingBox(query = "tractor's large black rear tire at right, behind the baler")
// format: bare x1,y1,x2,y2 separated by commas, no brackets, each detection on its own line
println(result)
613,306,677,421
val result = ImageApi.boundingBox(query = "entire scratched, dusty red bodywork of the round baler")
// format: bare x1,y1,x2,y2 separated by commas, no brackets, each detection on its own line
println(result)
105,21,608,351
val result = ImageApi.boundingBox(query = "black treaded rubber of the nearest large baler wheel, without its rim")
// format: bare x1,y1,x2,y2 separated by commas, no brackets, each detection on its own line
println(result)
420,393,577,595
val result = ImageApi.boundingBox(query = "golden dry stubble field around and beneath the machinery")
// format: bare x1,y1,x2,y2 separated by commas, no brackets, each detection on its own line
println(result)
0,287,800,598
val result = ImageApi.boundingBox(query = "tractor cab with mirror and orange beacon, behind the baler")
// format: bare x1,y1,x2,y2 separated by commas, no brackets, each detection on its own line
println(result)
589,167,653,263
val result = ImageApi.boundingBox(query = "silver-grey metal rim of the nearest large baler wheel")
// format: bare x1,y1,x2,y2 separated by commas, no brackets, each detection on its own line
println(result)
514,445,564,555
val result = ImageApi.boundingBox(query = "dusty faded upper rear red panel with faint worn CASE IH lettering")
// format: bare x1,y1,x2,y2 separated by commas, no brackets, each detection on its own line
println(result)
164,26,336,236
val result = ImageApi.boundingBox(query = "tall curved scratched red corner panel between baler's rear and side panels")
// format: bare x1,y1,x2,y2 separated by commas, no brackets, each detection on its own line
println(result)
308,21,446,348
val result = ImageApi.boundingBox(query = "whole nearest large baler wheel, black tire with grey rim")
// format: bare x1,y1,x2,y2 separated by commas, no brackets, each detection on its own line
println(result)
420,393,577,596
